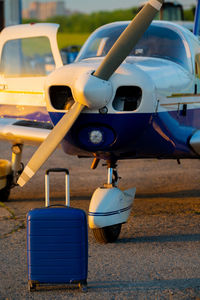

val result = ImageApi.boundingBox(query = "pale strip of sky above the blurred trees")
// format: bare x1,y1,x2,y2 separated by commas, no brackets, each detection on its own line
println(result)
22,0,196,13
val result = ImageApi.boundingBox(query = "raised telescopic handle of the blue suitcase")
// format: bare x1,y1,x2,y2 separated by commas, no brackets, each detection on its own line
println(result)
45,168,70,207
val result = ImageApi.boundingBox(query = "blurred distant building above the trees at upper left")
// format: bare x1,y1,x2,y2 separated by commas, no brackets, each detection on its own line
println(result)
22,1,69,20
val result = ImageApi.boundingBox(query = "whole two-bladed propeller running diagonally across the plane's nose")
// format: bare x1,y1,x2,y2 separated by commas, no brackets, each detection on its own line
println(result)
17,0,164,186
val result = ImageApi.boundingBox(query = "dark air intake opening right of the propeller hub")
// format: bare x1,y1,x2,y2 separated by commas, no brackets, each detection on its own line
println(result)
113,86,142,111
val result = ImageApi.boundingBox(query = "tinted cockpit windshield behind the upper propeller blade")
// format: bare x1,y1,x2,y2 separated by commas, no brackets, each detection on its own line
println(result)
77,23,189,69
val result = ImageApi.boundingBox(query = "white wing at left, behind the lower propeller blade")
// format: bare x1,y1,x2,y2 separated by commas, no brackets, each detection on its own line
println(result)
0,118,53,145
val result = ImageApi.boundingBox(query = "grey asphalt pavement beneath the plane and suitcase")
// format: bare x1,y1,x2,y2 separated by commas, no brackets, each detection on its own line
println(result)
0,142,200,300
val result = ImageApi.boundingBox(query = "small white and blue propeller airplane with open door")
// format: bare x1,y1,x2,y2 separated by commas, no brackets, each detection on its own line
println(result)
0,0,200,243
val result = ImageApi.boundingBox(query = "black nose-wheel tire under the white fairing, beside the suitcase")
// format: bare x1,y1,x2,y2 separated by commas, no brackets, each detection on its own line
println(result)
92,224,122,244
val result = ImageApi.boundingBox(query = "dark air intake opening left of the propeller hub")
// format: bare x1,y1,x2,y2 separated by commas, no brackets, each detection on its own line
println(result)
49,85,74,110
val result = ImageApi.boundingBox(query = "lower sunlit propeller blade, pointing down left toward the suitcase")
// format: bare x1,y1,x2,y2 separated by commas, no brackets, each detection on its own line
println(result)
17,102,84,186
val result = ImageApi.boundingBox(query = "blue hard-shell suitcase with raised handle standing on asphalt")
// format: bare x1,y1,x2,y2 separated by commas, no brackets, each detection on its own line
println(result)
27,168,88,291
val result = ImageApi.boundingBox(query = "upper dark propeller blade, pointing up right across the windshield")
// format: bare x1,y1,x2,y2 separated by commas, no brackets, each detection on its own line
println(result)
93,0,164,80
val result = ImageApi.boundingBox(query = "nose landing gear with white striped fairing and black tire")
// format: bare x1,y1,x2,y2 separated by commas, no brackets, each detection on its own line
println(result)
89,162,135,244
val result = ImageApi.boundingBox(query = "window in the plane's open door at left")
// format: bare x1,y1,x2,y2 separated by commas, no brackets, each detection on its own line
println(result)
0,37,55,77
